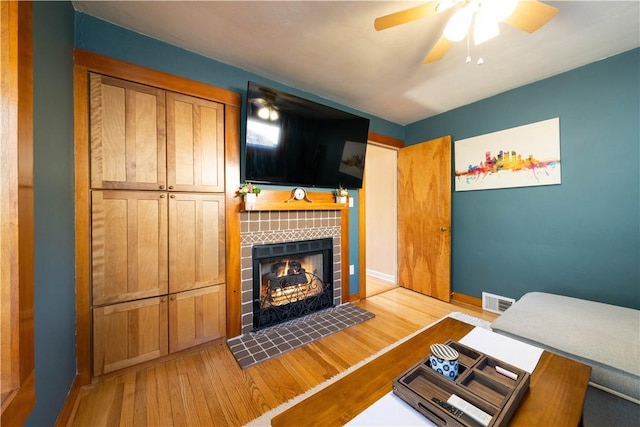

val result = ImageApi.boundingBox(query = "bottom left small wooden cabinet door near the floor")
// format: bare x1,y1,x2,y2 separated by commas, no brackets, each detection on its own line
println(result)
93,297,168,375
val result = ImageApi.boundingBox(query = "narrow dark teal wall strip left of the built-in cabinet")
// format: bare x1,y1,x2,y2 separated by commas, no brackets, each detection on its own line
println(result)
25,2,76,426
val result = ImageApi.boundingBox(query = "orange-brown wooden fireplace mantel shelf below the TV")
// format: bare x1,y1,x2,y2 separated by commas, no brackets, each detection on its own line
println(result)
241,190,349,211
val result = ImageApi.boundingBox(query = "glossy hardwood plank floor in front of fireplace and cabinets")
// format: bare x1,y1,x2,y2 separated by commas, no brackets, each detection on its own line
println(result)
69,288,497,427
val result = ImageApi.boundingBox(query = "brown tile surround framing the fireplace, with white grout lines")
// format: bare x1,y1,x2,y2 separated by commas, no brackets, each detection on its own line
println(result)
240,210,342,334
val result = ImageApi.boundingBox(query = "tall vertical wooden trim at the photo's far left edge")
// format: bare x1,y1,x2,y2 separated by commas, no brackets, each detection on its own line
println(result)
0,1,35,426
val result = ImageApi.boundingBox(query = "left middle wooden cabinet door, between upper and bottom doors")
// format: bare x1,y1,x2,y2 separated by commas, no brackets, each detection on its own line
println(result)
91,190,168,306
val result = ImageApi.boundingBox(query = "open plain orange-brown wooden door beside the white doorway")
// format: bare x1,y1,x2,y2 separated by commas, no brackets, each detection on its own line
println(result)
398,136,451,302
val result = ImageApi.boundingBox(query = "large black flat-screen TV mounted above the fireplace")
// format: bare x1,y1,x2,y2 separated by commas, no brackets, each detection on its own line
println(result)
244,82,369,188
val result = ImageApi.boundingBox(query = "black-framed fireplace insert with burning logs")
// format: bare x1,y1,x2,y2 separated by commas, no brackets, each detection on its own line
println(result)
252,238,333,331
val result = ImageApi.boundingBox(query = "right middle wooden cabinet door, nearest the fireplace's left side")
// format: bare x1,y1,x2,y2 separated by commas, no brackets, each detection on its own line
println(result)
169,193,225,293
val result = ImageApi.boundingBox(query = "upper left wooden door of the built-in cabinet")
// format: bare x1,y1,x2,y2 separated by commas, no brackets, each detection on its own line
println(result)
89,74,167,190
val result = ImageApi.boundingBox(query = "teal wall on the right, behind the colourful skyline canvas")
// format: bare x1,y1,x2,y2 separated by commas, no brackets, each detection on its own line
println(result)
400,49,640,308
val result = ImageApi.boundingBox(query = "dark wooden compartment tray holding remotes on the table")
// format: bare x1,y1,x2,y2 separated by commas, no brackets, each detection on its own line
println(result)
393,340,530,427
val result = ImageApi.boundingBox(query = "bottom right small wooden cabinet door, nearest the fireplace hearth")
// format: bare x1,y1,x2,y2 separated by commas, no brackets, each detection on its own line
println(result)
169,285,225,352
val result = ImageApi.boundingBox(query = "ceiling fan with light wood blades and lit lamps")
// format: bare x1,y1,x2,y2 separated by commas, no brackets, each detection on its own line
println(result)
374,0,558,64
